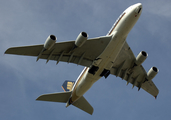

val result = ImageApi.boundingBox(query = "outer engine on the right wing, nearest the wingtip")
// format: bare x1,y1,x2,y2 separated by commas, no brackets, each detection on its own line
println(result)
147,67,159,80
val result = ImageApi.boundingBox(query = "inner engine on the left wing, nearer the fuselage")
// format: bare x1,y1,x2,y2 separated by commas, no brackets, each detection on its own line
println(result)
75,32,88,47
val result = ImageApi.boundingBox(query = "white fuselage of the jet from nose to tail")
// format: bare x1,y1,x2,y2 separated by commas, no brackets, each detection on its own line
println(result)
67,3,142,106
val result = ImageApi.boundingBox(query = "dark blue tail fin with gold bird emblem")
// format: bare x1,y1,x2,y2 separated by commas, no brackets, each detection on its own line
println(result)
62,80,75,91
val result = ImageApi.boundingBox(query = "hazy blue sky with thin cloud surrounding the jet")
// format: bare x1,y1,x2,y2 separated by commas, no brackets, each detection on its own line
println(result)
0,0,171,120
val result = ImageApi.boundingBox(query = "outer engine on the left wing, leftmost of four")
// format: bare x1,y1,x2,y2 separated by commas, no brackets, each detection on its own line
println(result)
44,35,57,50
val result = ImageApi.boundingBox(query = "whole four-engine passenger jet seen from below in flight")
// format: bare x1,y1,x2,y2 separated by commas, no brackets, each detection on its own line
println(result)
5,3,159,115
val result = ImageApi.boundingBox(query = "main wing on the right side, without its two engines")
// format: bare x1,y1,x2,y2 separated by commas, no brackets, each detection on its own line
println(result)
110,42,159,97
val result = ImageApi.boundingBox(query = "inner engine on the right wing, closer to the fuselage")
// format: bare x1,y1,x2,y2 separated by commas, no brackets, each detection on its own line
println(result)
135,51,148,65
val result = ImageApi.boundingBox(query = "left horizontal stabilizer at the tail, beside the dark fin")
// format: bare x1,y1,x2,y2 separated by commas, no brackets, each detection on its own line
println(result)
36,92,71,103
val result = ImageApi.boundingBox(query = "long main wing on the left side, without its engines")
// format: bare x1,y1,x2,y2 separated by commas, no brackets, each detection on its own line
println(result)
5,36,111,67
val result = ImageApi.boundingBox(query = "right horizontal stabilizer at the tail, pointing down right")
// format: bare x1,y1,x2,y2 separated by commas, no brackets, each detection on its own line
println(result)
72,96,93,115
